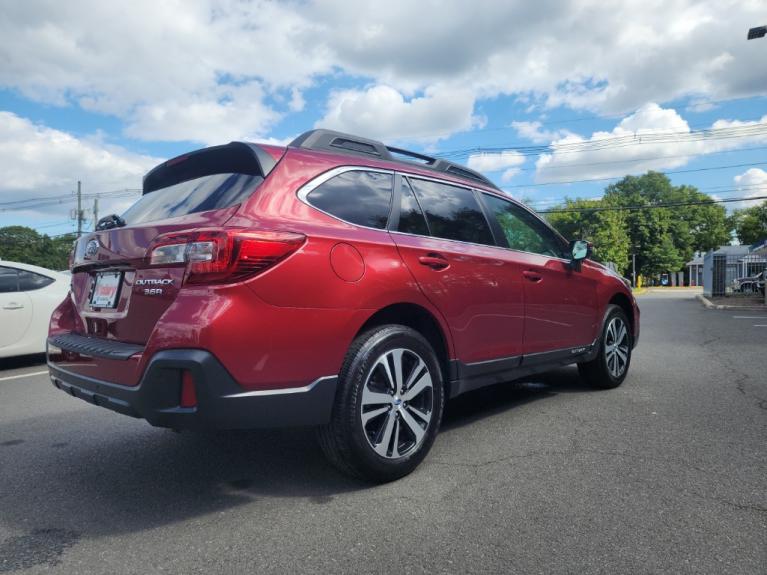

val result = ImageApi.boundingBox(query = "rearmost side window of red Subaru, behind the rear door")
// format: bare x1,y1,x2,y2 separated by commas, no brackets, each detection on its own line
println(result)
306,170,392,229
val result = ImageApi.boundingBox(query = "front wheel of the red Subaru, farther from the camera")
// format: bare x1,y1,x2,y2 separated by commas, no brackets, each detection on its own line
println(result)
578,305,634,389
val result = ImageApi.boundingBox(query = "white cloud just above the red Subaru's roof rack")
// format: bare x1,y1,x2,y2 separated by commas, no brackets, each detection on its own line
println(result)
316,86,482,141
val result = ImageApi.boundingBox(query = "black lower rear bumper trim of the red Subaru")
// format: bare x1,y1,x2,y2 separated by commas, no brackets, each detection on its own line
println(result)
48,342,337,429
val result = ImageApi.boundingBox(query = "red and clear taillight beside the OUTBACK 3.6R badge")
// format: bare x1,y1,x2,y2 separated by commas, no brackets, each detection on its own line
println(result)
148,230,306,283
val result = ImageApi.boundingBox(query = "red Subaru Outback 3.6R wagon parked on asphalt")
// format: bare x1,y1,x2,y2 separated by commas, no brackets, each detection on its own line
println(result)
48,130,639,481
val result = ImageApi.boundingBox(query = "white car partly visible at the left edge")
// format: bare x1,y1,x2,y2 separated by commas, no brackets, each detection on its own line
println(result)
0,260,70,357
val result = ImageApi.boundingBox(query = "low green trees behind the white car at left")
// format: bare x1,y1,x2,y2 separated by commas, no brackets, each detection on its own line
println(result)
0,226,75,270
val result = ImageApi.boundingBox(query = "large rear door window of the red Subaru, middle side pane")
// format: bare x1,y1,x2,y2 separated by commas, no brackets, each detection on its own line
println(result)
411,179,495,245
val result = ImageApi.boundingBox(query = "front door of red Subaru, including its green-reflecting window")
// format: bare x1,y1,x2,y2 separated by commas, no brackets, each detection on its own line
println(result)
482,193,597,359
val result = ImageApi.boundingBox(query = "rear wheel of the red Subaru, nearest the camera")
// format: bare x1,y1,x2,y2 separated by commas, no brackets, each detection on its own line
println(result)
318,325,444,483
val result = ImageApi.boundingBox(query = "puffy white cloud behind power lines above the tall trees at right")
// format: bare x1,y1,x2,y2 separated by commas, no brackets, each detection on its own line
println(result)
536,103,767,183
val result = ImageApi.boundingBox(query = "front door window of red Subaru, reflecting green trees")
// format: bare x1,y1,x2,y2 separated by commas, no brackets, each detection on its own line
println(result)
483,194,564,257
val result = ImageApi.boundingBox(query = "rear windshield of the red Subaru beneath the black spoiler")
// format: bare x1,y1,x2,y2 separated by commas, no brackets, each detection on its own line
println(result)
122,174,264,226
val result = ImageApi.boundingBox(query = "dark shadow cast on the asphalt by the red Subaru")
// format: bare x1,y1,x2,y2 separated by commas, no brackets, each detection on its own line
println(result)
0,368,589,538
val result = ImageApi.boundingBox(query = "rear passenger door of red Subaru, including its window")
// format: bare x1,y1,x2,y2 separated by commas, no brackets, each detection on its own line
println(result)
390,176,524,364
